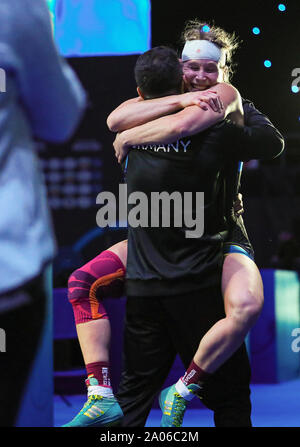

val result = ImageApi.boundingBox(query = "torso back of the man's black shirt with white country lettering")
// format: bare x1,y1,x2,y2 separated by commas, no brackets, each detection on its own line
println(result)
126,126,232,296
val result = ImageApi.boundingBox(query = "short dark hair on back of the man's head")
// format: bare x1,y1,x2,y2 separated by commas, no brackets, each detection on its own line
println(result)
134,46,182,99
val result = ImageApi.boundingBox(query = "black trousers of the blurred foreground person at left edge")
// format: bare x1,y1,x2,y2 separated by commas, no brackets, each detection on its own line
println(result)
0,276,46,427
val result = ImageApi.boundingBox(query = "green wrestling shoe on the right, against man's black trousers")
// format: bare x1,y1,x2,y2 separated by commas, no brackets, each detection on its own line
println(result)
159,383,201,427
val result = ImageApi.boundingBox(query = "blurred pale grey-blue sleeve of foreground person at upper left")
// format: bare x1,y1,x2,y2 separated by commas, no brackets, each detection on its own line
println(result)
0,0,86,142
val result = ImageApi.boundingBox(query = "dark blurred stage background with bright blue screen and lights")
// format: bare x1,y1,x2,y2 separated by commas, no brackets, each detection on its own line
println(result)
19,0,300,426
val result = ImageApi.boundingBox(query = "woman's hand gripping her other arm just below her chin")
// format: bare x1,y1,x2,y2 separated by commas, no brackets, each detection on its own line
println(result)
181,90,224,113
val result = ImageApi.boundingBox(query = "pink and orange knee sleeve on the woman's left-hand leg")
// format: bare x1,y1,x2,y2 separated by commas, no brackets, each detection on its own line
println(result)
68,250,125,324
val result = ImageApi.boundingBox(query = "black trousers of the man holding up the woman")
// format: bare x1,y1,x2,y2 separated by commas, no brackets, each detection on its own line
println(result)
117,287,251,427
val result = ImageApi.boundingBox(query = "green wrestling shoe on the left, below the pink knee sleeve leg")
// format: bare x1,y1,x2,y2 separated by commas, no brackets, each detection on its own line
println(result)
63,379,123,427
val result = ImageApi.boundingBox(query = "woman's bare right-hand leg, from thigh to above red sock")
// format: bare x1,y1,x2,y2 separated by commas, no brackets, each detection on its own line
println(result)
194,253,264,373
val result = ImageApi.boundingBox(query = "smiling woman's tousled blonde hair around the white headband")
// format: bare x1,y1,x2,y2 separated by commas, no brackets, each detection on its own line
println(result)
181,19,242,82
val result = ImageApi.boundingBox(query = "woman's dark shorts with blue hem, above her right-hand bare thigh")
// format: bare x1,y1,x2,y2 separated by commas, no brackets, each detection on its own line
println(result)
223,216,254,261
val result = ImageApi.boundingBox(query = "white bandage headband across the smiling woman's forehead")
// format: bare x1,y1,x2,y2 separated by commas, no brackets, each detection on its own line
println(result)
181,39,226,66
